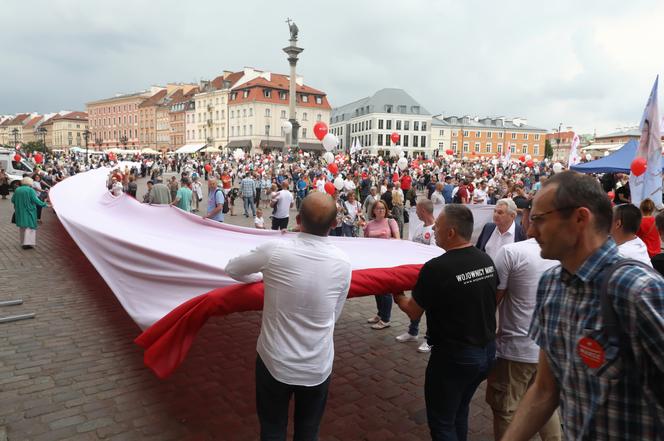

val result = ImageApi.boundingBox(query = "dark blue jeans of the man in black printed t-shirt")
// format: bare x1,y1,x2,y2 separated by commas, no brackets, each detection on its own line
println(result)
424,342,496,441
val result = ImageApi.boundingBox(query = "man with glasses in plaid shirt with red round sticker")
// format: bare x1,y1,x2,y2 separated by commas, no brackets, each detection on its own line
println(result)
503,172,664,441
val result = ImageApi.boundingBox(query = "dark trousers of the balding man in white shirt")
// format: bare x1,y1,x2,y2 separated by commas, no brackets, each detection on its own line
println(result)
256,356,330,441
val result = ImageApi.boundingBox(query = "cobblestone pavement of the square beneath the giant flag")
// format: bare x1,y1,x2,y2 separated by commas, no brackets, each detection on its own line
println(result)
0,174,491,441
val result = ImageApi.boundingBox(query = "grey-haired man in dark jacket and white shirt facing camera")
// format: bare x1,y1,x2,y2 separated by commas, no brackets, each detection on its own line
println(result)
476,198,526,260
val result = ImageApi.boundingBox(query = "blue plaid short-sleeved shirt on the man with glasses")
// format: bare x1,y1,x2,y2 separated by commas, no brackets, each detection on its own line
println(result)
530,239,664,440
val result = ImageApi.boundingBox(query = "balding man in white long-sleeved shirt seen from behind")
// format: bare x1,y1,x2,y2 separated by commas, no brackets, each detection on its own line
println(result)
225,192,351,441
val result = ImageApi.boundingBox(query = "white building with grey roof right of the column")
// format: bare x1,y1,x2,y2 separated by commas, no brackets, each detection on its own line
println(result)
330,88,430,158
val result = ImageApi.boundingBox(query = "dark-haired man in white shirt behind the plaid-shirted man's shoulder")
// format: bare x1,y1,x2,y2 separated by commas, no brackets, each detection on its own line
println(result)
611,204,652,266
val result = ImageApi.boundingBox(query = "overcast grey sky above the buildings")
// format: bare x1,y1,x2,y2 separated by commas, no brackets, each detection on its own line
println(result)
0,0,664,133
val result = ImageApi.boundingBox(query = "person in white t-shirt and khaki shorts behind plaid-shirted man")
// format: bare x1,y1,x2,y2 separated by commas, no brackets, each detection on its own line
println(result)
486,238,561,441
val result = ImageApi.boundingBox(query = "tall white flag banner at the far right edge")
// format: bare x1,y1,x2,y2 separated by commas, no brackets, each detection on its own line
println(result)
629,75,662,209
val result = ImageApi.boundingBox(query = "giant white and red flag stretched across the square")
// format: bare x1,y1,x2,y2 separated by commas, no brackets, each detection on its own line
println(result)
50,165,442,378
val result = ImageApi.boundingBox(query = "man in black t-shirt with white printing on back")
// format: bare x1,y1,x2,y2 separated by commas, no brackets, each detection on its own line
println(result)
394,204,498,441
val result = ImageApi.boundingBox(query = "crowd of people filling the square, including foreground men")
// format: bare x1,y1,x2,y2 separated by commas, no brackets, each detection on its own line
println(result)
0,152,664,440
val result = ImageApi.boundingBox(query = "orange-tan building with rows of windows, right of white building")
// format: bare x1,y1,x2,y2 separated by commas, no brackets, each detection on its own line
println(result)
437,116,546,160
